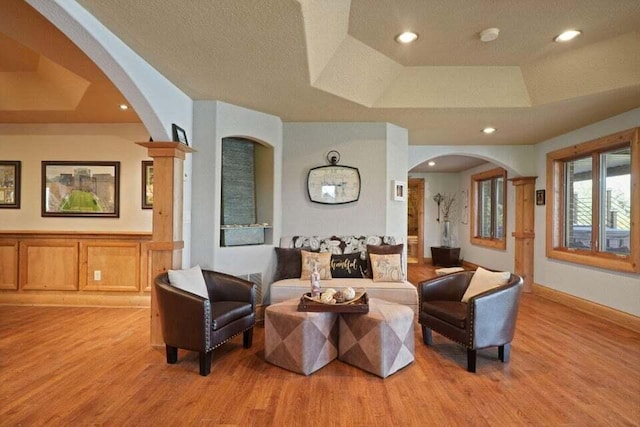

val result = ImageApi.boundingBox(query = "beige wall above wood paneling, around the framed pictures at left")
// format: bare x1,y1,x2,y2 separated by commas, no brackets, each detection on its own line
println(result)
0,124,152,232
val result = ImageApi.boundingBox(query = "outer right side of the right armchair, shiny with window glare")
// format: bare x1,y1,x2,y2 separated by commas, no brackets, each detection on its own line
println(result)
468,275,522,349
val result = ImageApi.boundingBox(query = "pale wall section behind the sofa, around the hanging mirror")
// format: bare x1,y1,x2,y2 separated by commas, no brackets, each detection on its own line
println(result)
282,123,388,236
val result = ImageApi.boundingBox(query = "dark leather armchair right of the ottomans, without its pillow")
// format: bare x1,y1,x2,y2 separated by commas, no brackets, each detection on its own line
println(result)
418,271,522,372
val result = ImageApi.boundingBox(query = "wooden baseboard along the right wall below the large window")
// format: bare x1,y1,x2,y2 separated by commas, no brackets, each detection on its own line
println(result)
533,283,640,332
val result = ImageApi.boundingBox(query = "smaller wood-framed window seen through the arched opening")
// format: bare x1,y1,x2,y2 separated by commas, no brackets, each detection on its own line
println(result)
471,168,507,249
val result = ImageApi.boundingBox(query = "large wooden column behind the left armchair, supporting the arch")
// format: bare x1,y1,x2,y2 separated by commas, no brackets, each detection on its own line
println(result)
136,142,194,346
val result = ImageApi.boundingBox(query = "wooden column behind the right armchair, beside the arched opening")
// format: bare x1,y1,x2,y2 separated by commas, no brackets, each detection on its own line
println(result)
509,176,538,292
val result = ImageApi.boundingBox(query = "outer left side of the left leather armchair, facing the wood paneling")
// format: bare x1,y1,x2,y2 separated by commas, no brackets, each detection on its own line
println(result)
156,279,211,351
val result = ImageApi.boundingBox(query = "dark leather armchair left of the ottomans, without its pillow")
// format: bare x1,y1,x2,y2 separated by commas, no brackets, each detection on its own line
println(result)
155,270,256,376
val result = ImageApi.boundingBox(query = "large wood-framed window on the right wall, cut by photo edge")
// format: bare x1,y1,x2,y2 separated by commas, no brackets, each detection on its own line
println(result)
546,128,640,272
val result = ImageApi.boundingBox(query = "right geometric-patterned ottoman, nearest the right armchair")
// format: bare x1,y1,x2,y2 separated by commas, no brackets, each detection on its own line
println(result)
338,298,414,378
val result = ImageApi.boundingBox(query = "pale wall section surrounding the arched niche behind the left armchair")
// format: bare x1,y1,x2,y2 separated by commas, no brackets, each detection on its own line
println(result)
191,101,282,286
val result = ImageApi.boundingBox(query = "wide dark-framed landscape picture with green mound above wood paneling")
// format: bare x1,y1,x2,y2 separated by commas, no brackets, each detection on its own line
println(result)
42,161,120,218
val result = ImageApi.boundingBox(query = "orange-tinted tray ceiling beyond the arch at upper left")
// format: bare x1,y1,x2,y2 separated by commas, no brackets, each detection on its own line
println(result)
0,0,140,123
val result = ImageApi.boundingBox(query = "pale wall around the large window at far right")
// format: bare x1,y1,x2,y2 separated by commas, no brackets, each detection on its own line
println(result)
534,109,640,316
